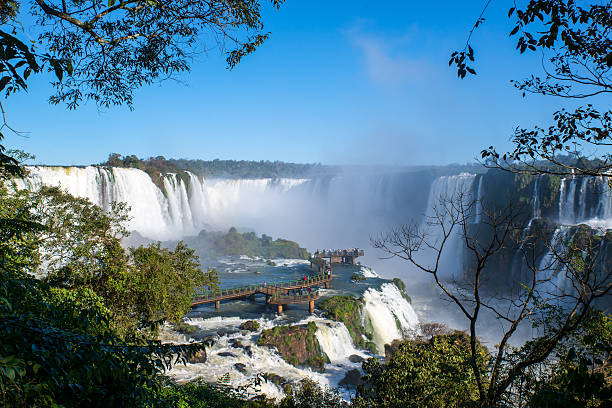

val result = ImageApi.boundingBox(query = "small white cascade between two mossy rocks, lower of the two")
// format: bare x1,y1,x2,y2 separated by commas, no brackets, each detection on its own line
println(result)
316,321,363,364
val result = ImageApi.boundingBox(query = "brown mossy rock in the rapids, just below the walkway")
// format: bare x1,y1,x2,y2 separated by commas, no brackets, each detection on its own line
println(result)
257,322,329,372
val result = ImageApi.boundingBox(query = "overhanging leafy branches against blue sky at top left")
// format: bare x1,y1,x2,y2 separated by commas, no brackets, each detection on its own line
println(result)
1,0,283,108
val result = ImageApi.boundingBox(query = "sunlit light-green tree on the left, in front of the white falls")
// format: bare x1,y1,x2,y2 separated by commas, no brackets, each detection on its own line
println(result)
0,187,218,337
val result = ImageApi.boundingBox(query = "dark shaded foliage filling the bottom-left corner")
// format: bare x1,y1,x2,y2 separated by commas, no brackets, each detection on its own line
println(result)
0,231,203,407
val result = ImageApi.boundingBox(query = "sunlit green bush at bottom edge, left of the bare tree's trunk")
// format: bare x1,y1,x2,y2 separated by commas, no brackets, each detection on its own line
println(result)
352,332,489,408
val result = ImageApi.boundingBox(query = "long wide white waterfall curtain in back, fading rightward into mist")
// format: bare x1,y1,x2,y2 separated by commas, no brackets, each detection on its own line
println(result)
17,166,440,262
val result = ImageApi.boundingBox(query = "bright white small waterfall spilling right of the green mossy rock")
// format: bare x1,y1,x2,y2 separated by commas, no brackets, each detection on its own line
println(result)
363,283,419,353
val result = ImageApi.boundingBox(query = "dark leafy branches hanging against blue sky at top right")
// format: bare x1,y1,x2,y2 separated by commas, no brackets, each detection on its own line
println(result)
449,0,612,176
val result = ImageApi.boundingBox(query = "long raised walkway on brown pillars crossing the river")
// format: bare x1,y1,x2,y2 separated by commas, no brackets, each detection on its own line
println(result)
191,272,332,314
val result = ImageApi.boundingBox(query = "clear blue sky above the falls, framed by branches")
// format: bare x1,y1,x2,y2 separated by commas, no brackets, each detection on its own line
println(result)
5,0,588,165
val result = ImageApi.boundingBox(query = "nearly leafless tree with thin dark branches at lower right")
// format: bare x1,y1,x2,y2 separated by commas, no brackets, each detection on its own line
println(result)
373,192,612,407
